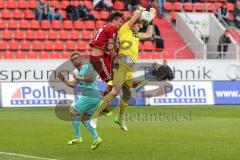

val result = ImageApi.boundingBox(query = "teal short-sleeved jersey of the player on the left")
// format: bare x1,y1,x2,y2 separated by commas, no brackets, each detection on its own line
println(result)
77,64,101,99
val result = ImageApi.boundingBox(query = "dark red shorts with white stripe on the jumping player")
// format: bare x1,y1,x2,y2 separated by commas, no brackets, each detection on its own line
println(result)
90,55,113,82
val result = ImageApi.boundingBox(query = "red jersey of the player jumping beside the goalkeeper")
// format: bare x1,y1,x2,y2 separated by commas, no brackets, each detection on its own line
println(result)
90,23,118,50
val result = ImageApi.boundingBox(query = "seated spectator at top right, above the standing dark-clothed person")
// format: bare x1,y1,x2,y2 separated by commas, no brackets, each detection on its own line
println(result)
217,3,230,25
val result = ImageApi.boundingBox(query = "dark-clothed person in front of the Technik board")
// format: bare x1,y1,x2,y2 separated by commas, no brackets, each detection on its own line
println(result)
152,60,174,81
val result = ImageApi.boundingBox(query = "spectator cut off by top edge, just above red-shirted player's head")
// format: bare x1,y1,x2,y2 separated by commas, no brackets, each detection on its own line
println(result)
93,0,113,11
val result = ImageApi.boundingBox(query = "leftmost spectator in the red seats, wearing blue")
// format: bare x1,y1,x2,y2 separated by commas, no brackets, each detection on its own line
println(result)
35,0,48,22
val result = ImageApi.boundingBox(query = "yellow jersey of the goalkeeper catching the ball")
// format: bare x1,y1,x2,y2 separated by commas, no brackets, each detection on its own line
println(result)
118,23,139,63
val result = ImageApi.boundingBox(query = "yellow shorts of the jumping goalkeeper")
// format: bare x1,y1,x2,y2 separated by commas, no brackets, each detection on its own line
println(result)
113,61,133,88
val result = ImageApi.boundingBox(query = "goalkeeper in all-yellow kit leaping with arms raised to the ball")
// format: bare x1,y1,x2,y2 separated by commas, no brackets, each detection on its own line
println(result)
92,7,156,131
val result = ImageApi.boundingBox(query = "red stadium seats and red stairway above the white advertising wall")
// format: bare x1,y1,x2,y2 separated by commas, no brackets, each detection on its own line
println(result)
0,0,237,59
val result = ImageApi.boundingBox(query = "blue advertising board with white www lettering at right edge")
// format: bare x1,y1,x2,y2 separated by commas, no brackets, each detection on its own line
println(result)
213,81,240,105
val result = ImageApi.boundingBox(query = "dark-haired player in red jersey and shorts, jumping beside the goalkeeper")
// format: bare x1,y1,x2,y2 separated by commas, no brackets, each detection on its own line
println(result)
90,11,147,112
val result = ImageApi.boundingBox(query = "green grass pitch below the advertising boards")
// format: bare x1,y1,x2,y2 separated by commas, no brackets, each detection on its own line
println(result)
0,106,240,160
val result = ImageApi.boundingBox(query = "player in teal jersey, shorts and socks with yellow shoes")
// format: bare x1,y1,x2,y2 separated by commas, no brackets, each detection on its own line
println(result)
57,53,102,149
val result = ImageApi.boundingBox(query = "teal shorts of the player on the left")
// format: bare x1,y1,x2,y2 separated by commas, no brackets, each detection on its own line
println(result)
71,96,101,115
